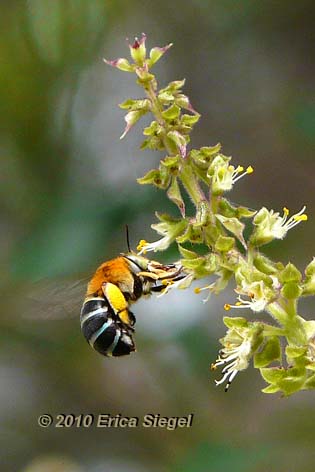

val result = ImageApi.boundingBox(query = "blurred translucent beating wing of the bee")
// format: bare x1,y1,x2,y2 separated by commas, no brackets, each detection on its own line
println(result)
19,278,88,320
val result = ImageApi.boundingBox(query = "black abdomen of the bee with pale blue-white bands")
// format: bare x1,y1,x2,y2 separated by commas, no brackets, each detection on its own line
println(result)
80,297,135,356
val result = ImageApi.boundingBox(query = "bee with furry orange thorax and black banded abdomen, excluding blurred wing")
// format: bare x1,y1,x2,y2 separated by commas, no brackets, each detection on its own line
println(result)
80,251,183,356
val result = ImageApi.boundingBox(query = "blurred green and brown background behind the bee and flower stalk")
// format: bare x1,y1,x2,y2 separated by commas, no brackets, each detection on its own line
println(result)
0,0,315,472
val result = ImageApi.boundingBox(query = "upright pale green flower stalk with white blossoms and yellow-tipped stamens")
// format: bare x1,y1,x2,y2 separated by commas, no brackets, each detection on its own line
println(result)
105,34,315,395
